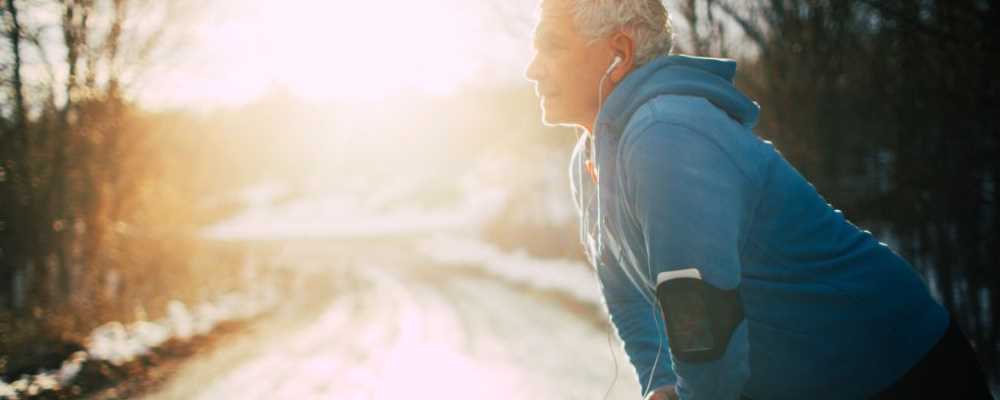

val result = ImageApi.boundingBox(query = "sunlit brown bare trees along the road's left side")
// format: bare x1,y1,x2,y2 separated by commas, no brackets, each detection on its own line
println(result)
0,0,266,377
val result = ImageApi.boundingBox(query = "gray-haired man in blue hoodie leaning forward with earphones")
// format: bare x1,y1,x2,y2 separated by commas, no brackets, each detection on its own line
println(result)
526,0,989,400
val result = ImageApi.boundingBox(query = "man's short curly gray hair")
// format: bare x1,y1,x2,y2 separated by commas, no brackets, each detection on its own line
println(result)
573,0,674,66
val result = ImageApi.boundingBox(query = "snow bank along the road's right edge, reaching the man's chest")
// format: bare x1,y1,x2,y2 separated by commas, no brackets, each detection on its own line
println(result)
417,234,602,305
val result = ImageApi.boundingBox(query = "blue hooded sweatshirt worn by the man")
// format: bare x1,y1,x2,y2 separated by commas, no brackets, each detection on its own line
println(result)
571,55,949,400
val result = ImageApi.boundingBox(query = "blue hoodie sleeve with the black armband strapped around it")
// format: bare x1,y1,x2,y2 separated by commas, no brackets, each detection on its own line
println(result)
620,122,750,400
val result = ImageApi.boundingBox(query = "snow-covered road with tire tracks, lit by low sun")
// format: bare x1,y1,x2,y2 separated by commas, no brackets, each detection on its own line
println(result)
139,242,639,400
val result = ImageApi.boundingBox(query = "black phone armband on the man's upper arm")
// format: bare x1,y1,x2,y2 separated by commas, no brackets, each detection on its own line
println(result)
656,268,744,363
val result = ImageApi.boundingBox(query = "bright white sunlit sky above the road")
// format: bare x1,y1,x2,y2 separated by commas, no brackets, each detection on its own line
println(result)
138,0,535,108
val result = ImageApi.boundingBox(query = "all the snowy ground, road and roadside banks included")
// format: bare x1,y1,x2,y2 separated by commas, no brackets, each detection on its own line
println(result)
0,164,639,400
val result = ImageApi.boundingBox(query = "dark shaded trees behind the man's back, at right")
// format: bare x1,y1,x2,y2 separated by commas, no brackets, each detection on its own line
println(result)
674,0,1000,378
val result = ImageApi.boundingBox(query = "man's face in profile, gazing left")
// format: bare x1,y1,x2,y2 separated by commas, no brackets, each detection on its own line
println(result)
525,0,613,128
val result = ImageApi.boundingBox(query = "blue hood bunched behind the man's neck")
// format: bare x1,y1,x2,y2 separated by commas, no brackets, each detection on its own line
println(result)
597,55,760,135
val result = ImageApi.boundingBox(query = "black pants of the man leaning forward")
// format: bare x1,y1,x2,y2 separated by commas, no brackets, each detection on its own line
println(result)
872,319,993,400
